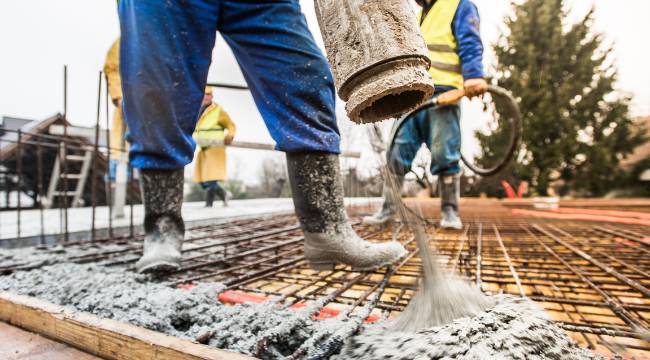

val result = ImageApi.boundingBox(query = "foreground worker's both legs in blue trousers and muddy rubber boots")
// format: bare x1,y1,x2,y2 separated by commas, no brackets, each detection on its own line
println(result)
118,0,406,273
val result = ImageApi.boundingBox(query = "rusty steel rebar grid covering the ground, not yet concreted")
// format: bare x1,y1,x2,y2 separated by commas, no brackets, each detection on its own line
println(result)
0,199,650,359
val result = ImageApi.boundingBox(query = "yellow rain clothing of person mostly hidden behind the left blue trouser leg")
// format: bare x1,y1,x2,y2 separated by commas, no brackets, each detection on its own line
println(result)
104,38,129,159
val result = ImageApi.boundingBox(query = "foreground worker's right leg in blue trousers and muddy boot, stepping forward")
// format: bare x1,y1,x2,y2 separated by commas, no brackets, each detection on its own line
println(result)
220,0,405,269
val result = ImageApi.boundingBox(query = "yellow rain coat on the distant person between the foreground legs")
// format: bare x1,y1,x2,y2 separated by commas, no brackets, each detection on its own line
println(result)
192,103,235,183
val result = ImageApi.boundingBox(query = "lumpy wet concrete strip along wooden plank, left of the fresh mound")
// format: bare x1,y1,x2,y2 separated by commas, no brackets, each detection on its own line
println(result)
0,263,349,358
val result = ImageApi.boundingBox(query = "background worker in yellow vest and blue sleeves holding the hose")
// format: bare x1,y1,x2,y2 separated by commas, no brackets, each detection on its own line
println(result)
363,0,488,229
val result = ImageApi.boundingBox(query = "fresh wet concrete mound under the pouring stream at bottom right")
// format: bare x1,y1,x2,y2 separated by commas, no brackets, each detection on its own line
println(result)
335,295,603,360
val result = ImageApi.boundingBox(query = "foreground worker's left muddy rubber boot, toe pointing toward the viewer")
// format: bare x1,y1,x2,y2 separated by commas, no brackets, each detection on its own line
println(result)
135,169,185,274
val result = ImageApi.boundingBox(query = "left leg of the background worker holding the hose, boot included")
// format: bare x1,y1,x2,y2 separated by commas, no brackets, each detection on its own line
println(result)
363,111,429,225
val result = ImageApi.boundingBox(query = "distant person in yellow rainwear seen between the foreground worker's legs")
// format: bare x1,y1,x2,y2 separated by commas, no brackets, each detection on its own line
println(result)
192,86,235,207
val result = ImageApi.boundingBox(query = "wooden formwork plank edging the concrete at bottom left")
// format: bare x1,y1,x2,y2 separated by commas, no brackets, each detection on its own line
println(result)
0,292,252,360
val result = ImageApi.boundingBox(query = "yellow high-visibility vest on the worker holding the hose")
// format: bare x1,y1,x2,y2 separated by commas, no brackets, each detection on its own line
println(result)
420,0,463,89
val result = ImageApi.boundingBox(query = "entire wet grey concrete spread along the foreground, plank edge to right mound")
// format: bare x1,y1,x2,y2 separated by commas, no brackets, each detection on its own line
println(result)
0,263,596,359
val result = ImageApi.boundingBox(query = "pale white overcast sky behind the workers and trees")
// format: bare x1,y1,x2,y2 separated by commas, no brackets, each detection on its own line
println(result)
0,0,650,181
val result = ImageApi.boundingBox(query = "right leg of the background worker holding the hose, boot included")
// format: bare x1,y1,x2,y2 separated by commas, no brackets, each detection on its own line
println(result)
429,105,463,229
